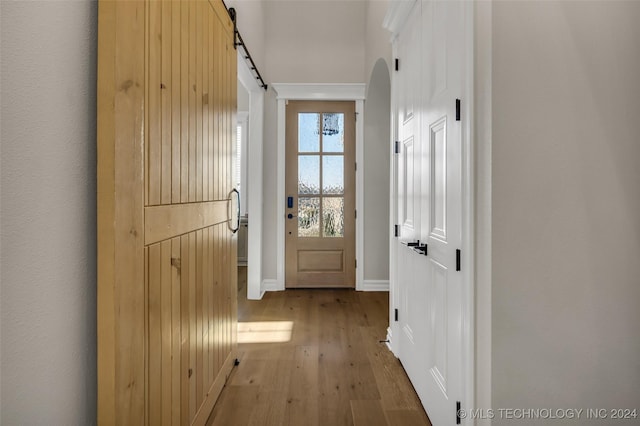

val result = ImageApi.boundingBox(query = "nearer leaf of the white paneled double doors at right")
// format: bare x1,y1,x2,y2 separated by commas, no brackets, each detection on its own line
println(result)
419,1,464,425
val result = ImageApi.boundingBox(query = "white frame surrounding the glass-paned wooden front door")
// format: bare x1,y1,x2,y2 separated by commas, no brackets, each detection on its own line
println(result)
262,83,366,291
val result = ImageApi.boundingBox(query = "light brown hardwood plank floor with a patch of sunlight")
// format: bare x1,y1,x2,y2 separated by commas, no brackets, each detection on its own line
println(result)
207,267,431,426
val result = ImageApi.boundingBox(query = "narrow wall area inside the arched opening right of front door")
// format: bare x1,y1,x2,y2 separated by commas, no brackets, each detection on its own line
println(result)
359,58,391,281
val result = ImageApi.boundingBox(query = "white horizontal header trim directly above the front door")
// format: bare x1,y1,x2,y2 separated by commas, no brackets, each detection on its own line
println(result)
271,83,366,101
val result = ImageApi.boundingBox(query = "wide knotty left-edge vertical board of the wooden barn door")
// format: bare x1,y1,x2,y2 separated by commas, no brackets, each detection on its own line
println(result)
97,2,146,424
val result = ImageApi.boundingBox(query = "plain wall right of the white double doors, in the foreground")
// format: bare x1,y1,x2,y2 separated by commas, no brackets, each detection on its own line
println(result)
492,2,640,424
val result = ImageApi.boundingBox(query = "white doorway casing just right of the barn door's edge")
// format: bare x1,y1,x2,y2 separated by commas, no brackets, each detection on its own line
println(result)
238,51,264,300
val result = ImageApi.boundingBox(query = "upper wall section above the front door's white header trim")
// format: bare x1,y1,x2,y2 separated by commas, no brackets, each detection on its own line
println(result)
264,0,366,83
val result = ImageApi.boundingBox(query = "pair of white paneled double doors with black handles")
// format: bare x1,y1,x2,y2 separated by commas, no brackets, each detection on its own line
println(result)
396,0,465,426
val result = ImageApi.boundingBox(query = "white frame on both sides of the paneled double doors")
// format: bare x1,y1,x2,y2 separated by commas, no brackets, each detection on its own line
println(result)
383,0,476,424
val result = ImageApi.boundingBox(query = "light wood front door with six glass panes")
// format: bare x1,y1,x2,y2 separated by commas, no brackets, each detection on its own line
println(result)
283,101,356,288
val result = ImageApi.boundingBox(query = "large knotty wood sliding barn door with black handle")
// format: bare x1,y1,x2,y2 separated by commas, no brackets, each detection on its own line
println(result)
98,0,237,425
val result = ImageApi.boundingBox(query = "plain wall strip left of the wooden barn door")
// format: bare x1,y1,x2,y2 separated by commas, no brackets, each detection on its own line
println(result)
0,1,97,425
